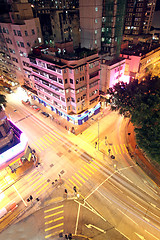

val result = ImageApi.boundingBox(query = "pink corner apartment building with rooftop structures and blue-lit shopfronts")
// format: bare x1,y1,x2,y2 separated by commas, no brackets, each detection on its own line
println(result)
29,42,100,124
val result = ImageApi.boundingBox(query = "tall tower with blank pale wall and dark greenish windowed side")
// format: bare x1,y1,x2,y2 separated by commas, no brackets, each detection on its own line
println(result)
79,0,126,57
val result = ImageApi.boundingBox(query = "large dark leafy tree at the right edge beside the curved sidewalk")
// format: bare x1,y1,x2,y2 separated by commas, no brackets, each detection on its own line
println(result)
108,75,160,162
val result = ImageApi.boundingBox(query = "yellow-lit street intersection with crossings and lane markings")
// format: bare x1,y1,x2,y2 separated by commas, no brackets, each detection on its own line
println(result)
0,91,160,240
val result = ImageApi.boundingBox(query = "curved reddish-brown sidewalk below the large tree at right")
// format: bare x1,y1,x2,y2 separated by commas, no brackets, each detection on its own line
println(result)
126,122,160,186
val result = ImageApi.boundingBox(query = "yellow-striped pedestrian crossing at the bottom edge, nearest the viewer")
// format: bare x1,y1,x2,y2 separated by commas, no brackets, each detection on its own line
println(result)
44,204,64,239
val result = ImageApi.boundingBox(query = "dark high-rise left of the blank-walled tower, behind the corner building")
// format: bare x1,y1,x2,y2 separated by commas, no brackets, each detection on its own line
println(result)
30,0,80,47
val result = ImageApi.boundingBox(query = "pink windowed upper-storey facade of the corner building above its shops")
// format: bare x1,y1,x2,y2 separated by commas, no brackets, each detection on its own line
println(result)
30,50,100,114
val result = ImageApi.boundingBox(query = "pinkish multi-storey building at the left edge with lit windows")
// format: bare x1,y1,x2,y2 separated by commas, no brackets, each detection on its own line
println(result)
0,2,43,86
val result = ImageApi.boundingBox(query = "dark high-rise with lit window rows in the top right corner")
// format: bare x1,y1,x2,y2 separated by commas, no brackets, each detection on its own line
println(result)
124,0,156,35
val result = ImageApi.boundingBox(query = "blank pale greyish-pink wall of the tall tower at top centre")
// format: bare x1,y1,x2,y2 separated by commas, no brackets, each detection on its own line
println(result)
79,0,102,50
